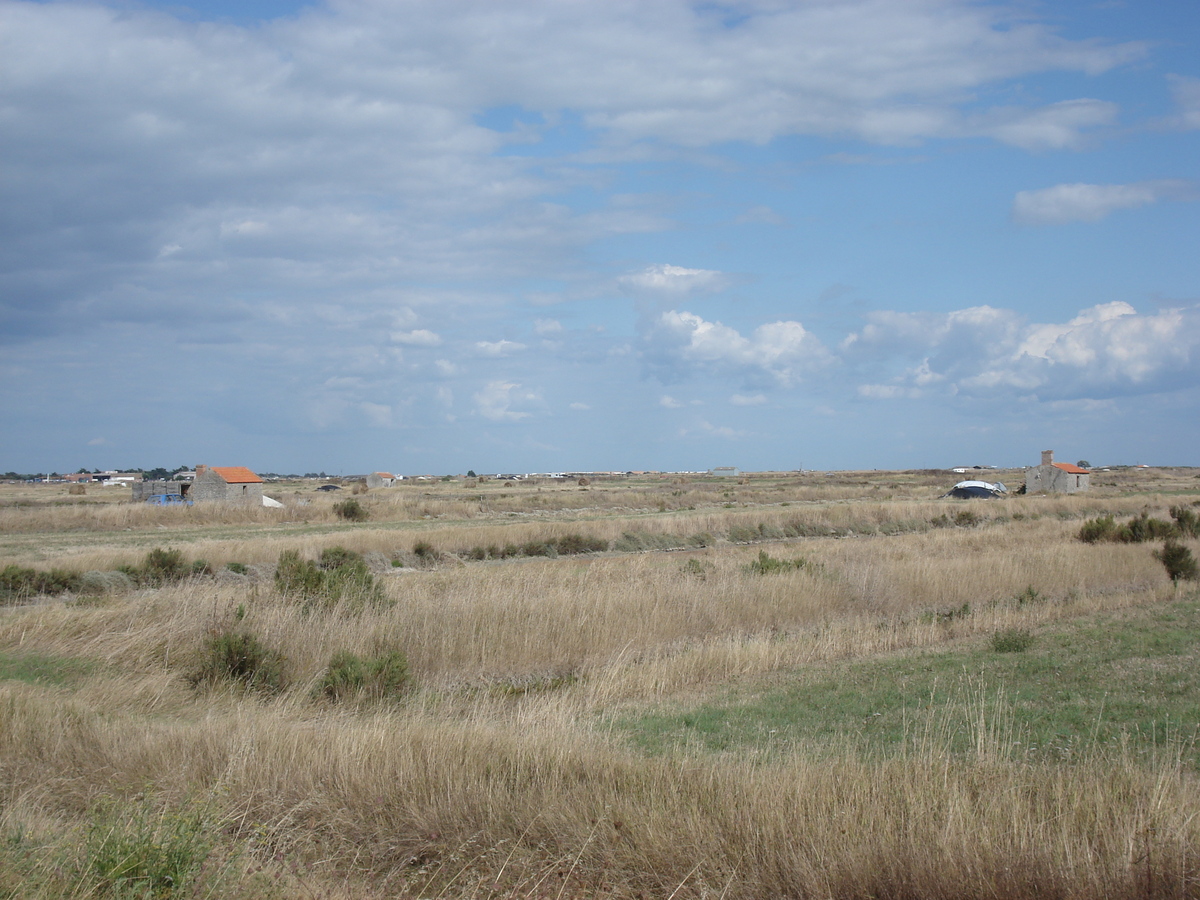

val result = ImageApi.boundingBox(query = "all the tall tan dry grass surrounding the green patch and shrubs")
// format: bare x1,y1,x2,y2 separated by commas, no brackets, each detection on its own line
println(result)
0,475,1200,899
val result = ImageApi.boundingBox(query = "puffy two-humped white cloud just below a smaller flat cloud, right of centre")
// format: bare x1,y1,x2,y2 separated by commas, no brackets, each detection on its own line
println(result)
644,310,833,385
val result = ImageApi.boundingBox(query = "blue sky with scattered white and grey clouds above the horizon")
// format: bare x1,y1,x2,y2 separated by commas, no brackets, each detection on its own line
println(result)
0,0,1200,474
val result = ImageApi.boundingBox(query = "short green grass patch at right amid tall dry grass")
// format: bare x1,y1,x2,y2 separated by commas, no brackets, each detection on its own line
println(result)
614,594,1200,766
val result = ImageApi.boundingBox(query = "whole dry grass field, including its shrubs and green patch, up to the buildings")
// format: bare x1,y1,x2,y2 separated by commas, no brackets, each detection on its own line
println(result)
0,469,1200,900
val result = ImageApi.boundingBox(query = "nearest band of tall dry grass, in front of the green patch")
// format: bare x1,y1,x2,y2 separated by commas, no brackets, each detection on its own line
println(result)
0,688,1200,898
